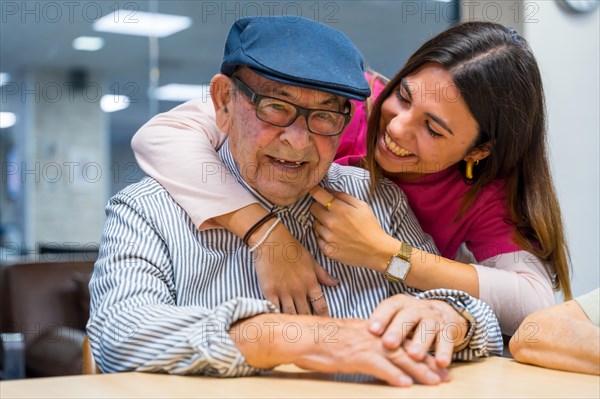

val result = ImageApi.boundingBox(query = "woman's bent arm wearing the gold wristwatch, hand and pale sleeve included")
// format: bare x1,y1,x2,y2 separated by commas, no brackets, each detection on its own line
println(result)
312,189,554,335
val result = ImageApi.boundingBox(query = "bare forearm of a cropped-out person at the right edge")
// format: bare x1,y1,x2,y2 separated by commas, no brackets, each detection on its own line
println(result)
509,292,600,375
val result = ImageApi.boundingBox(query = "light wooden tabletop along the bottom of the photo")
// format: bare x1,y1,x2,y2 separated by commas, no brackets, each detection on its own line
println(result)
0,357,600,399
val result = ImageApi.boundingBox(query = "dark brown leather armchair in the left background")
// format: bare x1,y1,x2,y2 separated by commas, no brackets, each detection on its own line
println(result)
0,256,94,377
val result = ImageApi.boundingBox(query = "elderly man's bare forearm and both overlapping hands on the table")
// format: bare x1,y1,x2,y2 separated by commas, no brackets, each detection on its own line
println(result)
236,294,467,386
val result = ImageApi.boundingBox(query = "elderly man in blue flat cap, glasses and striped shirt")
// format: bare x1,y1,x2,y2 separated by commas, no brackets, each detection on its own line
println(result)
87,17,502,386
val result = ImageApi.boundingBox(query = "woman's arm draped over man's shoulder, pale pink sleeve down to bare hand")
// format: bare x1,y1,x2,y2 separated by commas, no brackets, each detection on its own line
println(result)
131,100,337,315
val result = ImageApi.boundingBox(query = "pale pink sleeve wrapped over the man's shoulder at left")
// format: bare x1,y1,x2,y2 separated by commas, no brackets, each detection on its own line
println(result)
131,100,256,229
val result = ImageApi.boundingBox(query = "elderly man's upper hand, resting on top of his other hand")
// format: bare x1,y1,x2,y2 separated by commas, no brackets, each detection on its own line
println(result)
369,294,469,367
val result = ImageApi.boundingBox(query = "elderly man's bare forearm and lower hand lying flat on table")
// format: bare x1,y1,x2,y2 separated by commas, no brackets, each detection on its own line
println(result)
230,314,449,386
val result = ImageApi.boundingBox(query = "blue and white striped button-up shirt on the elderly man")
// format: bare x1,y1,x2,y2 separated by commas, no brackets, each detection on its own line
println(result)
87,142,502,376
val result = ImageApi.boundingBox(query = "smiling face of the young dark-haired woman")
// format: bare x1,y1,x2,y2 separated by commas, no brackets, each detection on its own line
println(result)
375,63,487,179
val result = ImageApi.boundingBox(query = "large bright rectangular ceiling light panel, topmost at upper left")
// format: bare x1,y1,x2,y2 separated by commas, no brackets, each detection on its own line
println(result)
94,10,192,37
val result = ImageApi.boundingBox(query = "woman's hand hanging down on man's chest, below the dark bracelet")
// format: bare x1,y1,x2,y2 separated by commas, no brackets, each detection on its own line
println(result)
253,224,338,316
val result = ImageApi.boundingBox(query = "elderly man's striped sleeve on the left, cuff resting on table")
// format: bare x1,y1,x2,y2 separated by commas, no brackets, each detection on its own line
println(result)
87,194,276,377
